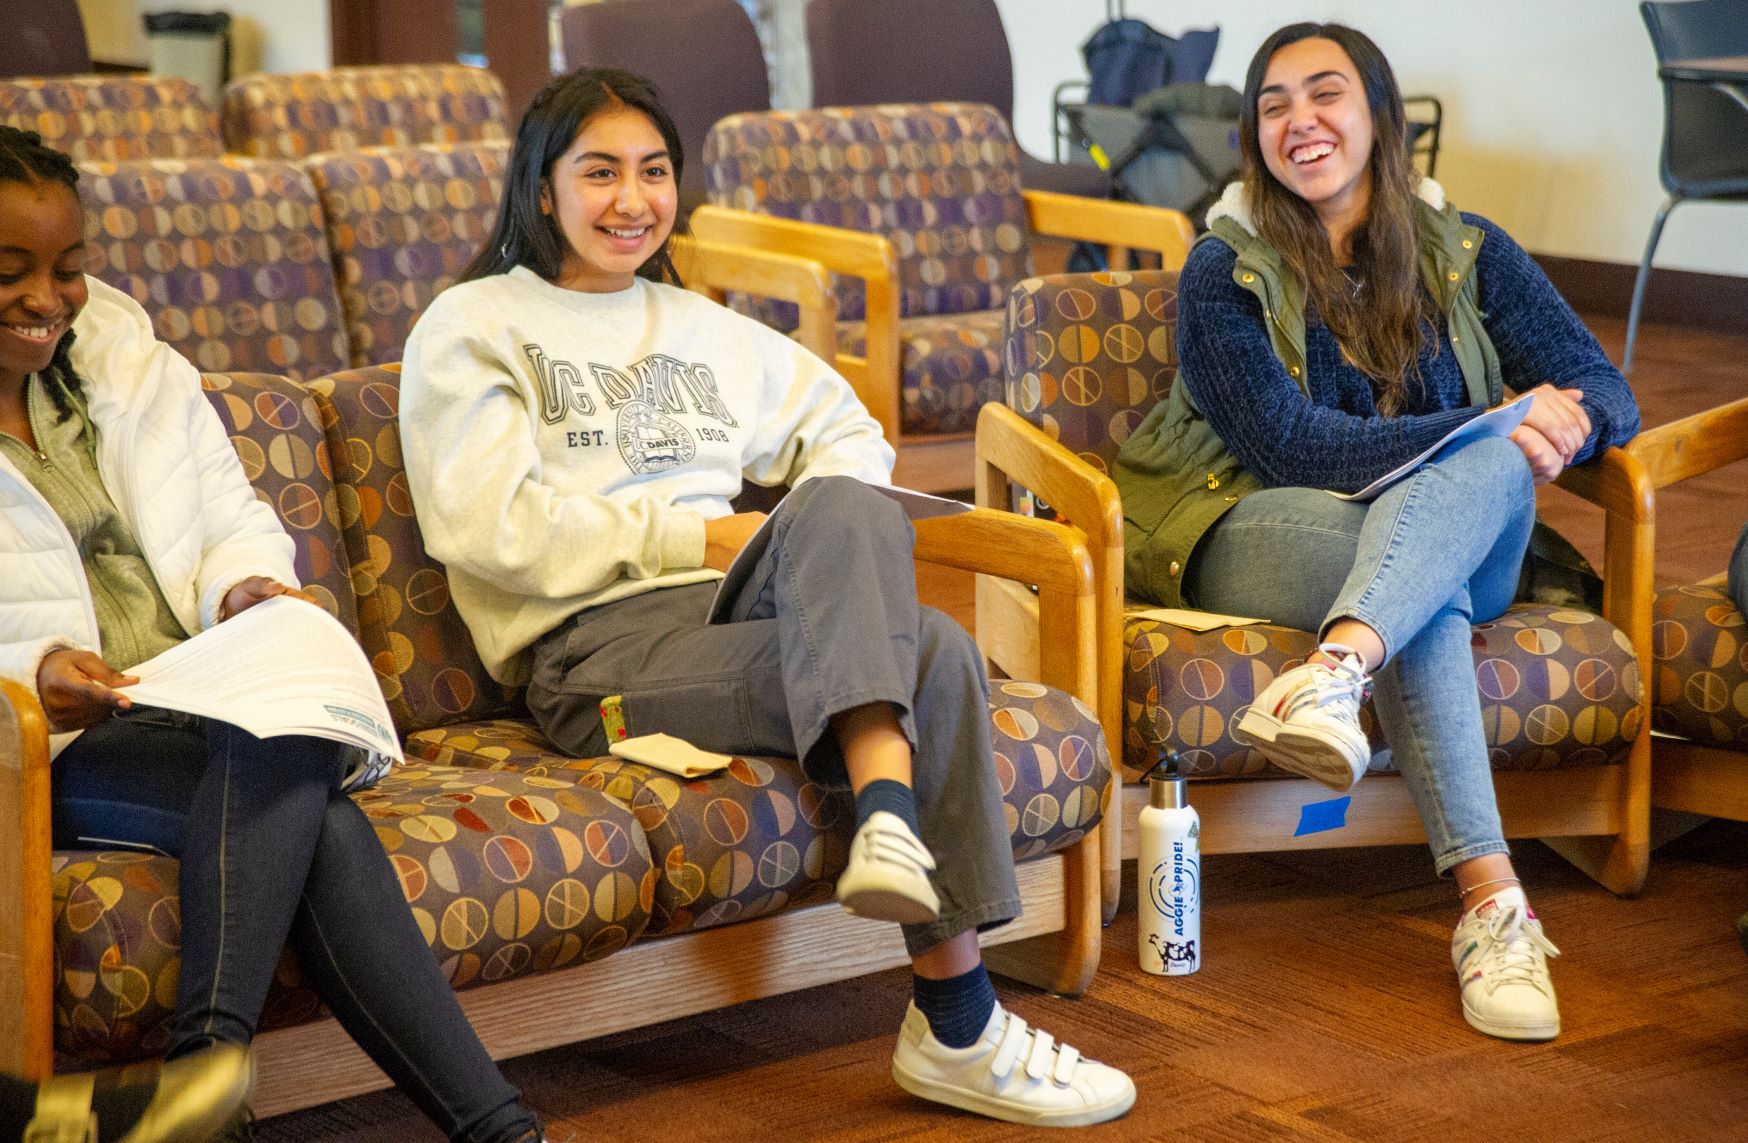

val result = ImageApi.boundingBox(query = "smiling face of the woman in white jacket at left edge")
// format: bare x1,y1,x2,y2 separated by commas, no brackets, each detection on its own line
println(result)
0,182,87,388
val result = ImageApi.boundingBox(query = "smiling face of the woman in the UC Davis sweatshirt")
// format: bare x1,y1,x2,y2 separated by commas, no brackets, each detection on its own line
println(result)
540,107,678,294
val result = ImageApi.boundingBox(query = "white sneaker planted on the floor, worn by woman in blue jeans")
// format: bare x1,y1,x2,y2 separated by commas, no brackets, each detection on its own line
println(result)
1451,890,1559,1040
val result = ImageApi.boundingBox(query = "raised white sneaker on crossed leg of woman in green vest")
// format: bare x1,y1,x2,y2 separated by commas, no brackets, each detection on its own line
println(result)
1234,643,1372,790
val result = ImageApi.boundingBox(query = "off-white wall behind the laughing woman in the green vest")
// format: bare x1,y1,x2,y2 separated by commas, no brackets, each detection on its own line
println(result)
999,0,1748,276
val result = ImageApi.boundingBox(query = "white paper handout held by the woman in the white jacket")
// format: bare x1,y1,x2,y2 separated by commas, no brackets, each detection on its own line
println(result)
121,596,404,762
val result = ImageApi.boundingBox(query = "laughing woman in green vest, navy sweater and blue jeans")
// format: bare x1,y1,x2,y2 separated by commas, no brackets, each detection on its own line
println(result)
1115,24,1638,1040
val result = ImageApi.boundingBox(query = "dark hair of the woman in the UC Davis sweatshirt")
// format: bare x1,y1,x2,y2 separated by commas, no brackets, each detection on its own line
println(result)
460,68,685,285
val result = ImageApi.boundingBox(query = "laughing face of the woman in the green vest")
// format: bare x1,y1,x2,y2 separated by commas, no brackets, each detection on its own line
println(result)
1257,37,1374,239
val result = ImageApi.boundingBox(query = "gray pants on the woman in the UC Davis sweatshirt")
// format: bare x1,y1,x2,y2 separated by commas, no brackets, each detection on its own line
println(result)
528,477,1019,956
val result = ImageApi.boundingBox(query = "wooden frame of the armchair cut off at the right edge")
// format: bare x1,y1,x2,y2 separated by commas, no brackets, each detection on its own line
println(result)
1627,397,1748,821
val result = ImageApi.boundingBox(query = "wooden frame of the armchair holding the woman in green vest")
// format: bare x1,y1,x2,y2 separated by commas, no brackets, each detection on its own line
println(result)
977,389,1657,919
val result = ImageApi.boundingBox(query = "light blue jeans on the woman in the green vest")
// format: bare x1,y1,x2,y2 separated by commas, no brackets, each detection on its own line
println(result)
1185,437,1535,874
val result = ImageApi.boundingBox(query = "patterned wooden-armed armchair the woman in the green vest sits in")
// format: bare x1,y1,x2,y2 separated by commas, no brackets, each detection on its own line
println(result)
977,273,1657,909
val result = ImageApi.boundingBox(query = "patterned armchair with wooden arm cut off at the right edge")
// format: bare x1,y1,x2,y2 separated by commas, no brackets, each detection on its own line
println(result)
1627,398,1748,821
